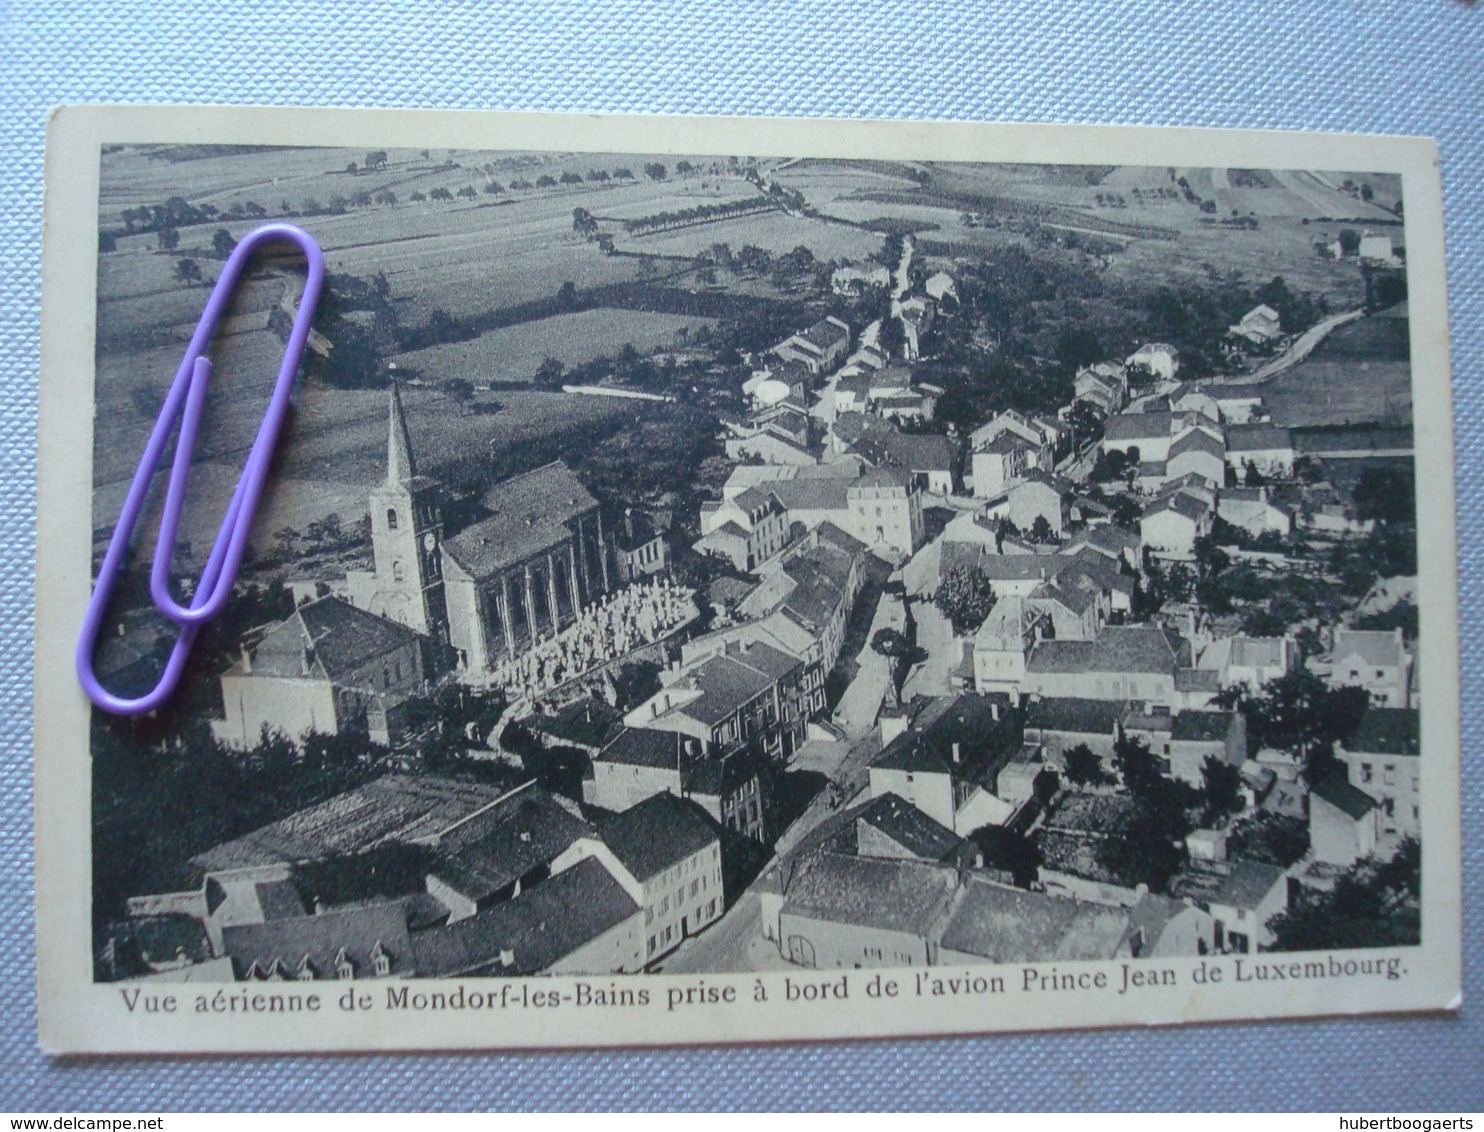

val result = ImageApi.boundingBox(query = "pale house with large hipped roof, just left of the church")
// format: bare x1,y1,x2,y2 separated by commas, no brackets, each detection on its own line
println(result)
211,598,435,751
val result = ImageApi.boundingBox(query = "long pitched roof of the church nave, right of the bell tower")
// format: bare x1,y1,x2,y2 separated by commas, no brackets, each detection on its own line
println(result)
444,460,598,582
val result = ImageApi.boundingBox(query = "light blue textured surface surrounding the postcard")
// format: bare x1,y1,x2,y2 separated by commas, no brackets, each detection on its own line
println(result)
0,0,1484,1111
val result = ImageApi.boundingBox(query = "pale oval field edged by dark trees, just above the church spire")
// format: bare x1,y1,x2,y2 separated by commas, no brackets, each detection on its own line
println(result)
392,307,711,386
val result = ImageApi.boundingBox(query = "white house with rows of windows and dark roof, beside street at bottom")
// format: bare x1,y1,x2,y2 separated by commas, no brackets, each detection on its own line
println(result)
552,792,726,964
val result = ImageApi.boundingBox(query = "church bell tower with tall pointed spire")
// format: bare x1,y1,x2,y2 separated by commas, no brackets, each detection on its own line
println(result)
371,381,448,642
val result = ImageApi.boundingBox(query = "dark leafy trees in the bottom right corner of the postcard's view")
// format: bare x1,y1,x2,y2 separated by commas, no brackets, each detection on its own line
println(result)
1267,837,1422,951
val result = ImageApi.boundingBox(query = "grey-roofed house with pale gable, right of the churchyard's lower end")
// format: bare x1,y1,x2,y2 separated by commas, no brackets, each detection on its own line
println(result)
623,641,824,761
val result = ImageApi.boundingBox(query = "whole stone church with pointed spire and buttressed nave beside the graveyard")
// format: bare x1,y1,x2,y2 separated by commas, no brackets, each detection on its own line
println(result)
346,384,616,682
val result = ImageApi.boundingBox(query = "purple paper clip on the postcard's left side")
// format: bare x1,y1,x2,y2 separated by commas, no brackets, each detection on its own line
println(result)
77,224,325,715
